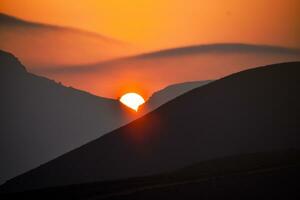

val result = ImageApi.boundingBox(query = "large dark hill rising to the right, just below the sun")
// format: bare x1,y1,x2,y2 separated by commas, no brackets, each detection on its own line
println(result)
3,62,300,191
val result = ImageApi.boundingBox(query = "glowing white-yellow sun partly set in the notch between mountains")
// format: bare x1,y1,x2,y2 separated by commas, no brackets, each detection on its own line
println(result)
120,92,145,112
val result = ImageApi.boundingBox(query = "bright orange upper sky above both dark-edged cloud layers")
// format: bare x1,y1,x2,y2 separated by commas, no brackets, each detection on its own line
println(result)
0,0,300,50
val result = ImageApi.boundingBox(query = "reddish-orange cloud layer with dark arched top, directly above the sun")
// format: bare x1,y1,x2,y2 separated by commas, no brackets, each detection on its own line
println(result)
39,43,300,98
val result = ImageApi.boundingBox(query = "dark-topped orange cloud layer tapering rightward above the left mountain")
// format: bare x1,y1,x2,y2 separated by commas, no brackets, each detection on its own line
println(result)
0,14,136,70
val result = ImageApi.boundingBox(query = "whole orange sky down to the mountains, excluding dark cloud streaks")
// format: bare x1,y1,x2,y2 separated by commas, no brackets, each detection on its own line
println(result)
0,0,300,98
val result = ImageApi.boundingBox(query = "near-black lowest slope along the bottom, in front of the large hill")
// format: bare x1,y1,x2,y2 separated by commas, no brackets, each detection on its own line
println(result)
0,150,300,200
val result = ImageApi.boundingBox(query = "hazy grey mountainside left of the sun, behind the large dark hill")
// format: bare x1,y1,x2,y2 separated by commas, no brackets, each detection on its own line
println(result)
0,51,129,184
